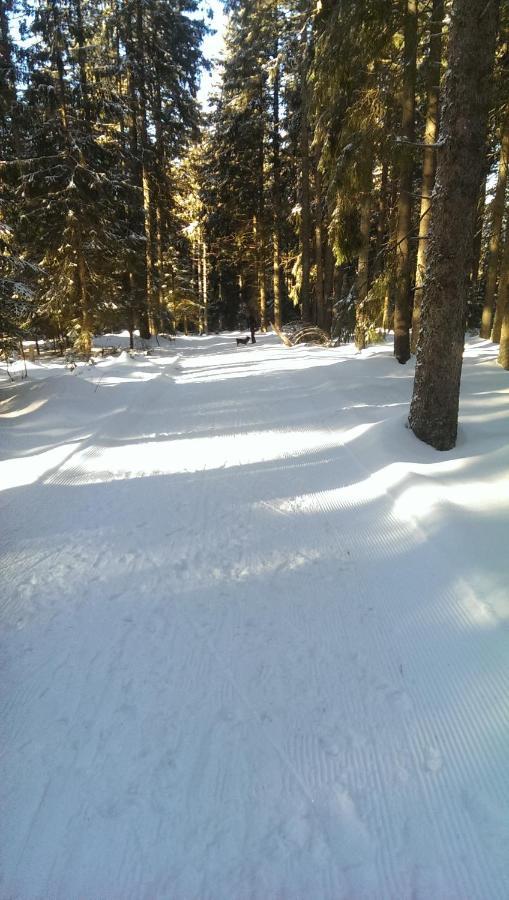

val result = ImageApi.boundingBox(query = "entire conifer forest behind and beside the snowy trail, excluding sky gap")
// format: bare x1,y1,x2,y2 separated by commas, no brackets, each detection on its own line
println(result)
0,0,509,449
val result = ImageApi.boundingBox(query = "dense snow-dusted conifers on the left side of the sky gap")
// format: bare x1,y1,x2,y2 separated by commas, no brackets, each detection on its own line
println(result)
0,0,205,353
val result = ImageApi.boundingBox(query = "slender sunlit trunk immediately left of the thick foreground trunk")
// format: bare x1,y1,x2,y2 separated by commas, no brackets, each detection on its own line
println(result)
412,0,444,353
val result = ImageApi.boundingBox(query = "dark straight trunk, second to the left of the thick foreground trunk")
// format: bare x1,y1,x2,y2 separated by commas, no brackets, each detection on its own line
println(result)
394,0,417,363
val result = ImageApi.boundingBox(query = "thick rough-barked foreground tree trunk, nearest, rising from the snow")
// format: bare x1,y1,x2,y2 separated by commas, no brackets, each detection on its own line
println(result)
409,0,499,450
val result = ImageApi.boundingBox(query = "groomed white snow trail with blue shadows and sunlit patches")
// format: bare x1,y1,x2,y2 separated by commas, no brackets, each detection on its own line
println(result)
0,335,509,900
